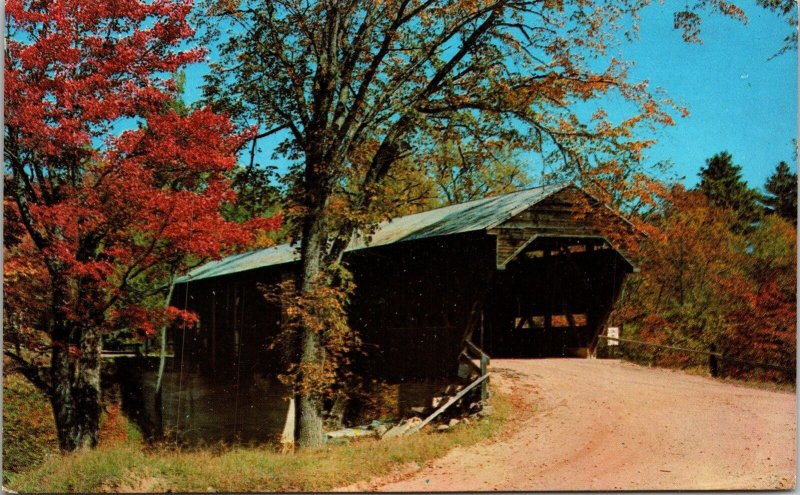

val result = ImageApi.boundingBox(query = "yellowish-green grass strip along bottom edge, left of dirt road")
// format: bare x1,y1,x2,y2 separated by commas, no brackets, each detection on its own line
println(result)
6,393,515,492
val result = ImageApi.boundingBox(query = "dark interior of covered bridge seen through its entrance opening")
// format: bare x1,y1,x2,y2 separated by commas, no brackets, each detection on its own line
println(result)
482,237,630,358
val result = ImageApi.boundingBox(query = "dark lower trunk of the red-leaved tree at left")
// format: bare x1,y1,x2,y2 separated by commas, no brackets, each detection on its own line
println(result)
50,321,101,451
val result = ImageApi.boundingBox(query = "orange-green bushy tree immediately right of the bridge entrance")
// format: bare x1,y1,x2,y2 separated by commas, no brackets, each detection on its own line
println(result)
618,186,745,364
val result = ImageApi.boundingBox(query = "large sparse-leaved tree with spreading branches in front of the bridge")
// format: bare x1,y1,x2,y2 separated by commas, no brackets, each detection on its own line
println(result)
198,0,743,446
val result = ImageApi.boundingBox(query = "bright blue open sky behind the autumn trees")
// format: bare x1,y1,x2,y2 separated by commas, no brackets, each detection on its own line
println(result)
186,0,797,188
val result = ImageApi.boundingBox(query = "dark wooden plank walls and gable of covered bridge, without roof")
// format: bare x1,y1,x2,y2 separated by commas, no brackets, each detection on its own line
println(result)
158,189,638,438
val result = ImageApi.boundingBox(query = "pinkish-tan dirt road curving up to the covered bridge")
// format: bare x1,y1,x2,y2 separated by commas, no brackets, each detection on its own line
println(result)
356,359,796,492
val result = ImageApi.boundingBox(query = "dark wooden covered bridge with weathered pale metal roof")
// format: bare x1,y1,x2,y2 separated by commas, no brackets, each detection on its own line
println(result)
138,184,640,444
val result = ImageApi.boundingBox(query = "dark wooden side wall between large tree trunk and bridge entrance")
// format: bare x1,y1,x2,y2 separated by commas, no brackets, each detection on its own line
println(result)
351,233,495,382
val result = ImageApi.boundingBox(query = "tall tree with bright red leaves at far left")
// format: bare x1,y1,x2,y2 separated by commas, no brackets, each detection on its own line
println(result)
4,0,274,450
